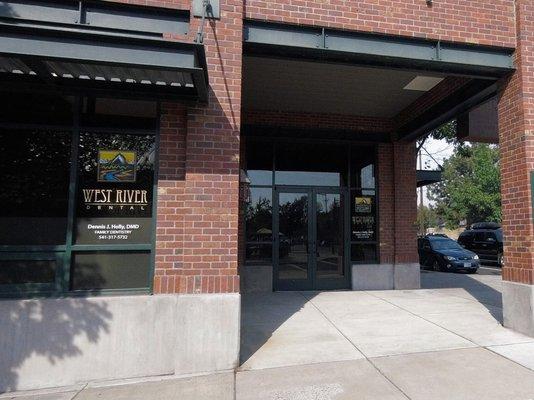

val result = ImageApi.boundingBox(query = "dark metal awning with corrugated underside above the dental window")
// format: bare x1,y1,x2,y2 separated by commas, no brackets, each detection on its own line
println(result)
0,22,208,102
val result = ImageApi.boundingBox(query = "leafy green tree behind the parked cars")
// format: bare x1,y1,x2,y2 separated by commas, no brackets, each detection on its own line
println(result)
429,144,501,229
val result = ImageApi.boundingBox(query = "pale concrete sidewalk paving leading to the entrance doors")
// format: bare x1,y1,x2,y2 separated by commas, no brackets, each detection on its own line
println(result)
0,272,534,400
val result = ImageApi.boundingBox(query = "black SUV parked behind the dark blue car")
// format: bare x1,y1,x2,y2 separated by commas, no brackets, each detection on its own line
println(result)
458,223,503,266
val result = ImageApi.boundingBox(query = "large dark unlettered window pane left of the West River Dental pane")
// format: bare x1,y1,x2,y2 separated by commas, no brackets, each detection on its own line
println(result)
0,129,71,246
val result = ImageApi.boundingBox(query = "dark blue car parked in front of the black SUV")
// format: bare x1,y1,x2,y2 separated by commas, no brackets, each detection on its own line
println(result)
417,236,480,273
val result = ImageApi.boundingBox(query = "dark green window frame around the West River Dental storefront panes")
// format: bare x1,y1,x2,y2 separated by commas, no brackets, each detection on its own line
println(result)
0,96,160,298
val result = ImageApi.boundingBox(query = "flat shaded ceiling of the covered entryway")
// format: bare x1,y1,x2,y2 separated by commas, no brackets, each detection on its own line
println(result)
243,56,444,118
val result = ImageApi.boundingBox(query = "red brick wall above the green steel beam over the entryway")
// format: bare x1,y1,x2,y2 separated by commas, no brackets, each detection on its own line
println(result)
245,0,515,47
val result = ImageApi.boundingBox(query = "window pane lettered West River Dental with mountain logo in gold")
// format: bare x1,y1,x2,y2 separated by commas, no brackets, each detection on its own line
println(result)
75,132,155,244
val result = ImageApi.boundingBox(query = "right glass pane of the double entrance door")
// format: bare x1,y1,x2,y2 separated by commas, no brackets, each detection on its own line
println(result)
316,193,343,278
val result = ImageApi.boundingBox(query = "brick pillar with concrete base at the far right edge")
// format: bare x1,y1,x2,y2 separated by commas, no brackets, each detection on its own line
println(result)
499,0,534,336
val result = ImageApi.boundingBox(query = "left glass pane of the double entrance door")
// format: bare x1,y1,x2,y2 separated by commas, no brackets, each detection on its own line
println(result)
278,193,308,279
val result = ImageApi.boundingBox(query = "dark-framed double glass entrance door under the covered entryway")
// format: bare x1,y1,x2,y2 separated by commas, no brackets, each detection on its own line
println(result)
274,187,349,290
